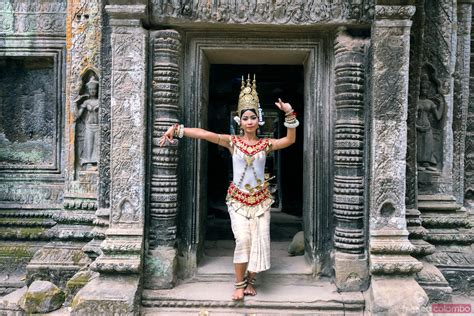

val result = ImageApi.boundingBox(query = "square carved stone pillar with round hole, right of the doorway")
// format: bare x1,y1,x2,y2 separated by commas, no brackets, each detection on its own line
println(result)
368,1,428,314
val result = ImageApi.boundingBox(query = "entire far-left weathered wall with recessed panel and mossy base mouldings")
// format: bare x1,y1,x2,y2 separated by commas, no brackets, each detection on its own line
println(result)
0,0,66,293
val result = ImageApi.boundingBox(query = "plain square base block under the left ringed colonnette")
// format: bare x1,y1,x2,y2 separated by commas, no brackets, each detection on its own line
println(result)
145,246,178,289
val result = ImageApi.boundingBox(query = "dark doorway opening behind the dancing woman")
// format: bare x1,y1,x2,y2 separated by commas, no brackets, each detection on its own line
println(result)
205,64,304,256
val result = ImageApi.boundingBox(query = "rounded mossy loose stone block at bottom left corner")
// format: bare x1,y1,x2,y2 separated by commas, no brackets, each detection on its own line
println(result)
20,281,64,313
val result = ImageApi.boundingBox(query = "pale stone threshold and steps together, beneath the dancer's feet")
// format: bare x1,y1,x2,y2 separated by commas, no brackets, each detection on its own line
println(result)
141,256,365,315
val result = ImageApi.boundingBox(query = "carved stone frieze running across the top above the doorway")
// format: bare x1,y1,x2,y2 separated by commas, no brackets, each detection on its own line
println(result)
151,0,374,25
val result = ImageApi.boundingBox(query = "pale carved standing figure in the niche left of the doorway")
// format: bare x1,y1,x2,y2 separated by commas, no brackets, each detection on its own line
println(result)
74,76,99,169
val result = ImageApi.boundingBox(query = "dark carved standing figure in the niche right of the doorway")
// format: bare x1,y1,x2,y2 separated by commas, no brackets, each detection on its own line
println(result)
416,73,445,171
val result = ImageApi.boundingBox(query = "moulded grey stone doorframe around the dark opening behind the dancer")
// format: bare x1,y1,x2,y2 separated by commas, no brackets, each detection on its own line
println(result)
178,31,333,276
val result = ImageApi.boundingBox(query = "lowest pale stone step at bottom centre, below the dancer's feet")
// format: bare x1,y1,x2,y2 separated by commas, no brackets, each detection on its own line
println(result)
142,280,365,315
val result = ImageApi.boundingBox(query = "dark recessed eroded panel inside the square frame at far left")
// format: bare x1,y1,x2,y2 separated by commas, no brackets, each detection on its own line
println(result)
0,57,59,169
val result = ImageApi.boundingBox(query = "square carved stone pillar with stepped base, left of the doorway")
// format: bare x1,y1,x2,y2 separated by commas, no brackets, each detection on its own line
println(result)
73,1,148,314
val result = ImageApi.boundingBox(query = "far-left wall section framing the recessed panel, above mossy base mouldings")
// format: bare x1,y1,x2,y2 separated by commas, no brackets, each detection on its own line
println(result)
0,0,66,209
